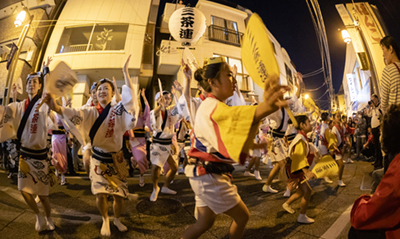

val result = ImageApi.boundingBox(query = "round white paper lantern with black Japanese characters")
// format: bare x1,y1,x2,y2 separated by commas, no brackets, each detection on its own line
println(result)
168,7,207,46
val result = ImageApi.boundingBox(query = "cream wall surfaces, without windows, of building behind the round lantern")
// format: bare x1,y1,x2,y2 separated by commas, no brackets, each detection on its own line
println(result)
158,0,296,102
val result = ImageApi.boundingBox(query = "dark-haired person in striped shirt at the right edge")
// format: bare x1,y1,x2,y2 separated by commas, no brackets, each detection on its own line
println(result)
380,36,400,113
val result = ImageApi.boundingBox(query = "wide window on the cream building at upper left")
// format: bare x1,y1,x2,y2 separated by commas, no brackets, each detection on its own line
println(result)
56,23,129,54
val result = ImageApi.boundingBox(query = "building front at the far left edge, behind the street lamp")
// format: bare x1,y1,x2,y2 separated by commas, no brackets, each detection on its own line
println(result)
0,0,64,101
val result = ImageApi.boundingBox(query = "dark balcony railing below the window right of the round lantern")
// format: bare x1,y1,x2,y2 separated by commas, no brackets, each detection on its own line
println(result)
208,25,243,46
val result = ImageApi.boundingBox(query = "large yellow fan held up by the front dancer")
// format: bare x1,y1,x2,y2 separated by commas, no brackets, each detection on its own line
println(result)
242,13,280,89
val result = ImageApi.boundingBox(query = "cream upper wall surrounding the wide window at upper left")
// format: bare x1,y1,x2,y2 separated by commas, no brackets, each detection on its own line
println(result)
46,0,152,70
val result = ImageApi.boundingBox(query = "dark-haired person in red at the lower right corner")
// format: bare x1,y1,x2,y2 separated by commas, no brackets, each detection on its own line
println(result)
348,105,400,239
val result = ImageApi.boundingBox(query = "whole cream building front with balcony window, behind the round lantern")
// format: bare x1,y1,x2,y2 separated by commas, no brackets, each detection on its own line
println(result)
152,0,296,104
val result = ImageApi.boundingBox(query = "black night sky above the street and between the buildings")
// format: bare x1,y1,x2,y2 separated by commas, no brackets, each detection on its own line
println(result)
159,0,400,109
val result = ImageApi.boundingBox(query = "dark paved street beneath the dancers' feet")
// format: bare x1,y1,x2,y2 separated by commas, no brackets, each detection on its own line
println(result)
0,161,373,239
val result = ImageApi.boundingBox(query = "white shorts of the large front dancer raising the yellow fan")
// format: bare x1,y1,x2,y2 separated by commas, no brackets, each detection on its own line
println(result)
189,174,242,214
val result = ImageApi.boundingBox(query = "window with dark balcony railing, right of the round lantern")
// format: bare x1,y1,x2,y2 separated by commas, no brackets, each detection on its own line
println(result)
209,16,243,46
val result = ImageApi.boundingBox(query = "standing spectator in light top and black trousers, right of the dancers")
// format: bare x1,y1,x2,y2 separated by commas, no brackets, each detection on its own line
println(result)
368,94,383,170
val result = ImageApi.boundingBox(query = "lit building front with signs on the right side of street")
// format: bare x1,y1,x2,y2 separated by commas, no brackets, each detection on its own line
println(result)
336,2,387,115
